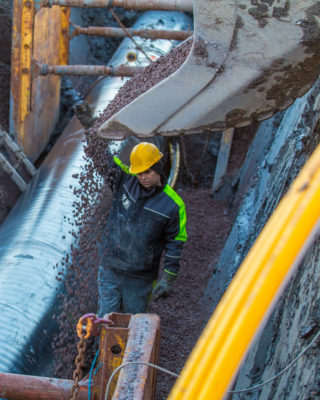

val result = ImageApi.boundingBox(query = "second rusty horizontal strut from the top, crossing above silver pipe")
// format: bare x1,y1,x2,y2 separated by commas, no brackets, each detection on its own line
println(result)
70,25,193,40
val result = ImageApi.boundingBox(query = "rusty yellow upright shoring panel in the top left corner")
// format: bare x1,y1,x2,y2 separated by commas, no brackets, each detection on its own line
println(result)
9,0,69,162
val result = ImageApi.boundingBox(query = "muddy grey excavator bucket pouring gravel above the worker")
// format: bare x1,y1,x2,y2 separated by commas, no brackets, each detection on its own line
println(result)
98,0,320,139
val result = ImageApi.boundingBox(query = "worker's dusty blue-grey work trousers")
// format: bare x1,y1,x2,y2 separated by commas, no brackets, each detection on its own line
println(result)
98,266,153,318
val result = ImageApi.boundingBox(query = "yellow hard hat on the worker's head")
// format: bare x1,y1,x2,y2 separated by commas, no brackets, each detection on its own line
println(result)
129,142,163,174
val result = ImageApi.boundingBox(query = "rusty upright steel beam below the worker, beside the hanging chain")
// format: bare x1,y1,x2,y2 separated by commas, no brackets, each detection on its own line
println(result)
94,313,160,400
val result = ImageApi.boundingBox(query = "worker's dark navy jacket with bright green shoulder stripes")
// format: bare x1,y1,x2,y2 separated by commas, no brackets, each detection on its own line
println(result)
100,157,187,280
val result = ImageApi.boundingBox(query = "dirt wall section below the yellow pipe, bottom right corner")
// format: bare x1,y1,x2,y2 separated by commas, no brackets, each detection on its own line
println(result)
232,236,320,400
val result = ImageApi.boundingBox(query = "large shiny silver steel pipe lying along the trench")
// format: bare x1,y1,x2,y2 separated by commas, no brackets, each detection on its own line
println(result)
0,11,192,375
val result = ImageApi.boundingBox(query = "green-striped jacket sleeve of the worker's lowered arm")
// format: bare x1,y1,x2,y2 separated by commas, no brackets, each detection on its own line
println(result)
164,202,187,275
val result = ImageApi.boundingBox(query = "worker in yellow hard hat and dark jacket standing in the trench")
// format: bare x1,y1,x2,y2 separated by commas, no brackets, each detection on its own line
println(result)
98,142,187,317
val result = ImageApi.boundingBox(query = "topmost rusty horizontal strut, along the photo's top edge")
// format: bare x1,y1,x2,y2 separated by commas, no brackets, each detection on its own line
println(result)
39,0,193,13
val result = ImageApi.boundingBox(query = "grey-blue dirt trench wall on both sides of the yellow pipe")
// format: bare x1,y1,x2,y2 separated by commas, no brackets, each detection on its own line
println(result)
203,76,320,400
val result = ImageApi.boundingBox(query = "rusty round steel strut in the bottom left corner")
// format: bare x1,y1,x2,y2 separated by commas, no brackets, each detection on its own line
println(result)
0,372,88,400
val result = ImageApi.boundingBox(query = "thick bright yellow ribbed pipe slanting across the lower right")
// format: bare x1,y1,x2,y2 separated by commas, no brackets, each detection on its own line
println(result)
168,141,320,400
